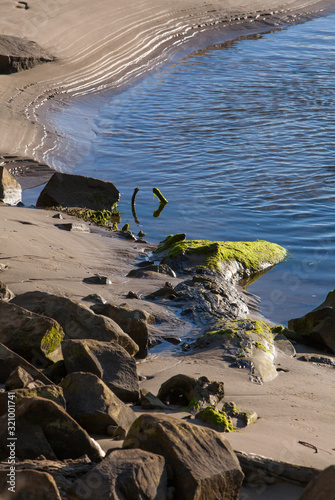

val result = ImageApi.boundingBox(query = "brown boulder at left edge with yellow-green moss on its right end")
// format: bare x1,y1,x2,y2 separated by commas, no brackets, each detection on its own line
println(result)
0,302,64,366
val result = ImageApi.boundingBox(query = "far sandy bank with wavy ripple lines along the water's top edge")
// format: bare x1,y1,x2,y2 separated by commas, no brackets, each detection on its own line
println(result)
0,0,334,185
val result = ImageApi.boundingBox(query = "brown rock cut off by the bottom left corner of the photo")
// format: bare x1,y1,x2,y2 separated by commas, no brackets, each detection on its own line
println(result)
0,469,61,500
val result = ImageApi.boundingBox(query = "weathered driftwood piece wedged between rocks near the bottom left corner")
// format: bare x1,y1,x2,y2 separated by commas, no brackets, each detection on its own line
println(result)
0,455,96,494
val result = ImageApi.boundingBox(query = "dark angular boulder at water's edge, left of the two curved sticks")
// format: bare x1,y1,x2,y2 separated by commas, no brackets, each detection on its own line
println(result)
36,172,120,210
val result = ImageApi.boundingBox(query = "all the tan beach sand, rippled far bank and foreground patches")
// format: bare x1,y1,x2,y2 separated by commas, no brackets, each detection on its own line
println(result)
0,0,335,499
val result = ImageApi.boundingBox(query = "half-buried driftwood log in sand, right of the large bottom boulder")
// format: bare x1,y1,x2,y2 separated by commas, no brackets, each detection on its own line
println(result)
235,451,321,486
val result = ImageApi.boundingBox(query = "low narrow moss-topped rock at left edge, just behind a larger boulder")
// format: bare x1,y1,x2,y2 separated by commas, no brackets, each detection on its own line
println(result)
0,385,66,415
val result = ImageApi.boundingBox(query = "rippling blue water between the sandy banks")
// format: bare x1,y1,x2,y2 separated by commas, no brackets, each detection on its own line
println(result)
39,15,335,324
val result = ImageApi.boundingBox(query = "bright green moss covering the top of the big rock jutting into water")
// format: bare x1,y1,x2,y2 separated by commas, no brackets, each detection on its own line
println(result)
156,234,287,273
